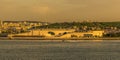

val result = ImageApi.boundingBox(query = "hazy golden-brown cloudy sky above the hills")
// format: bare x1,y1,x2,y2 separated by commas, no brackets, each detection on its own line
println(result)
0,0,120,22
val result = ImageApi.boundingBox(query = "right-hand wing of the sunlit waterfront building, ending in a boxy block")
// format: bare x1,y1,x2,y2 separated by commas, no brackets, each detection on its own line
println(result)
61,30,104,38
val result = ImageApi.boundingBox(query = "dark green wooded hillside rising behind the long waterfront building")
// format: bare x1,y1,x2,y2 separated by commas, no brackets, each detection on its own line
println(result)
34,22,120,29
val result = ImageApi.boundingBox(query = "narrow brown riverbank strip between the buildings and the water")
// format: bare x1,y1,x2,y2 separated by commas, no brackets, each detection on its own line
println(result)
0,37,120,40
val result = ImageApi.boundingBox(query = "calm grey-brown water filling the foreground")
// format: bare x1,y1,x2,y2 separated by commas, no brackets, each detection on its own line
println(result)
0,40,120,60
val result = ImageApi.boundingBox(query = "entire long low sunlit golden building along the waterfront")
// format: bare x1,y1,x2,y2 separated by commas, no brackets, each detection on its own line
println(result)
10,29,104,38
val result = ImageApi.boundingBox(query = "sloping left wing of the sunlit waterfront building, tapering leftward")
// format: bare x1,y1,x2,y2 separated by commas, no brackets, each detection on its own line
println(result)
13,29,75,37
